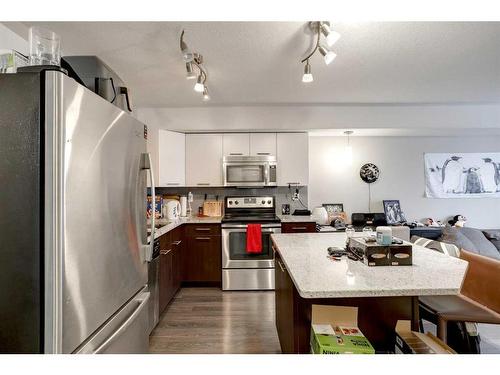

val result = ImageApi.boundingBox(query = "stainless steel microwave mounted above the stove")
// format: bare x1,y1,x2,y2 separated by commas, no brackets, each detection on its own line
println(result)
222,155,277,187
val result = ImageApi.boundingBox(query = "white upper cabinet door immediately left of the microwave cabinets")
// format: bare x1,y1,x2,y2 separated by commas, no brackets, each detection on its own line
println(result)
186,134,223,186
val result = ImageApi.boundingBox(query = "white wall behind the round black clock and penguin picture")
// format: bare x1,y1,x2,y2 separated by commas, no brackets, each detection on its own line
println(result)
309,136,500,228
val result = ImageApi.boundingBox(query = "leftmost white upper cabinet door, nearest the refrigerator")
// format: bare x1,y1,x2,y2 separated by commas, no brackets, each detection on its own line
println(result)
157,130,186,186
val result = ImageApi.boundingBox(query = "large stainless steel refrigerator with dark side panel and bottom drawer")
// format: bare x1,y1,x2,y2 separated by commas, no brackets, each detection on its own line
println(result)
0,68,154,353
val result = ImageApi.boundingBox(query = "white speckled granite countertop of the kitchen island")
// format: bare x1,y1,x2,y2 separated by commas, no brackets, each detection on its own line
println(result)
271,233,468,298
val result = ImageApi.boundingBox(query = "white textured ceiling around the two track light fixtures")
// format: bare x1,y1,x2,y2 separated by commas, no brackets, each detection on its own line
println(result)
3,22,500,107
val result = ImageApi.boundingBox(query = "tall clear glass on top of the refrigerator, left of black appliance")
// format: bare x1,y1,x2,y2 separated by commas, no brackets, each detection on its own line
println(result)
29,26,61,66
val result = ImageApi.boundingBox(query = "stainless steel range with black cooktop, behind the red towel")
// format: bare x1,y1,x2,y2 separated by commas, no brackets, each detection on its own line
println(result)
222,197,281,290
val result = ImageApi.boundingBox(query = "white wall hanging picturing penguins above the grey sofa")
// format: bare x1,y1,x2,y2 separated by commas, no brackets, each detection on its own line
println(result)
424,153,500,198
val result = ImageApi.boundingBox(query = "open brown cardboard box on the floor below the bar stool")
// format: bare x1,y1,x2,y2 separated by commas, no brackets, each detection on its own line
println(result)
394,320,456,354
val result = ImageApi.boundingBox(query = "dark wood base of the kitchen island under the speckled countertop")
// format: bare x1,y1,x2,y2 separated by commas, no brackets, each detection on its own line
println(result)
275,252,418,353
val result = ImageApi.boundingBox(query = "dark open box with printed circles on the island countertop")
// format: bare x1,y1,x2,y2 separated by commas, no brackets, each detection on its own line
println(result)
349,237,412,266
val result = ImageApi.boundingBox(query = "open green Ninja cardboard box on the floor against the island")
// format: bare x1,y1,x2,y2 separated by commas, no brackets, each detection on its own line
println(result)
310,305,375,354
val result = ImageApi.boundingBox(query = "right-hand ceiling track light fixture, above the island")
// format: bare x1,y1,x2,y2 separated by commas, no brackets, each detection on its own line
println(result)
301,21,340,83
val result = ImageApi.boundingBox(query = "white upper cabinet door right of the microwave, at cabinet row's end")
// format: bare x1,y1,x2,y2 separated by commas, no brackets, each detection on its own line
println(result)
276,133,309,186
